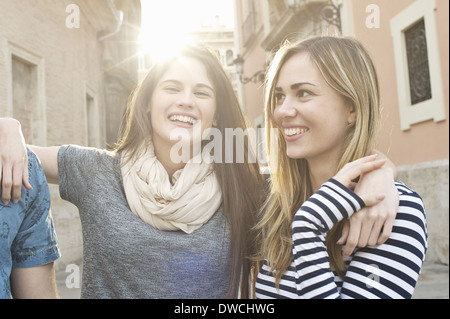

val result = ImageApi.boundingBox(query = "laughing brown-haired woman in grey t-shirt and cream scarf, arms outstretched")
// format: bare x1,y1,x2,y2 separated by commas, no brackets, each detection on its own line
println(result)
0,46,264,299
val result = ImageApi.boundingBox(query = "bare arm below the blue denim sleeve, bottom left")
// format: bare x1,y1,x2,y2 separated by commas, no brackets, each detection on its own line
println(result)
11,263,58,299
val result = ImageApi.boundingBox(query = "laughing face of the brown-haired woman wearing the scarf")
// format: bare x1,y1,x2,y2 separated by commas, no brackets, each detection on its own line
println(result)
150,57,216,159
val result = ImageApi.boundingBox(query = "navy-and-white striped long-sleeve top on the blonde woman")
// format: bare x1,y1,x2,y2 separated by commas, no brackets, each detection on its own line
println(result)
256,179,427,299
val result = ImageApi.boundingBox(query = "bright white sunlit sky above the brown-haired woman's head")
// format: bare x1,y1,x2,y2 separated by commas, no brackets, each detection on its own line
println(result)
141,0,234,54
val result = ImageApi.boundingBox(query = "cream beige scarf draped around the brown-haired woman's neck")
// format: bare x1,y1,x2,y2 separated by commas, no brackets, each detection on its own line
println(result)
122,145,222,233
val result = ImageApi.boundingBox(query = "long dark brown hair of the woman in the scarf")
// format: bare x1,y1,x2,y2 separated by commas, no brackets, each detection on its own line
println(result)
115,44,264,298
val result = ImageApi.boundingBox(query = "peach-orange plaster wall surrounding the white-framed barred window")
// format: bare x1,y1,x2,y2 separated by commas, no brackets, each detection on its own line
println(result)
352,0,449,165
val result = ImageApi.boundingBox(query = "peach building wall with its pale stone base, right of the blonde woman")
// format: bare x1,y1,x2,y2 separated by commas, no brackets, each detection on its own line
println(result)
352,0,449,264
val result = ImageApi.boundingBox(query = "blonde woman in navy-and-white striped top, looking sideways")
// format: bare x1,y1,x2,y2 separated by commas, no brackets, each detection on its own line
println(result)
256,37,427,298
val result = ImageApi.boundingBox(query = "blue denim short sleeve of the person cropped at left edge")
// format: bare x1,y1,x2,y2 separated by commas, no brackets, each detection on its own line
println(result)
11,151,60,268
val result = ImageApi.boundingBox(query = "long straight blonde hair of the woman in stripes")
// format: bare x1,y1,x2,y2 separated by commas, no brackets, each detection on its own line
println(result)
256,36,380,286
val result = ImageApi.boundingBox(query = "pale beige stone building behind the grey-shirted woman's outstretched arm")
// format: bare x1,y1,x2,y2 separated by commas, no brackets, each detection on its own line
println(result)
0,0,141,269
